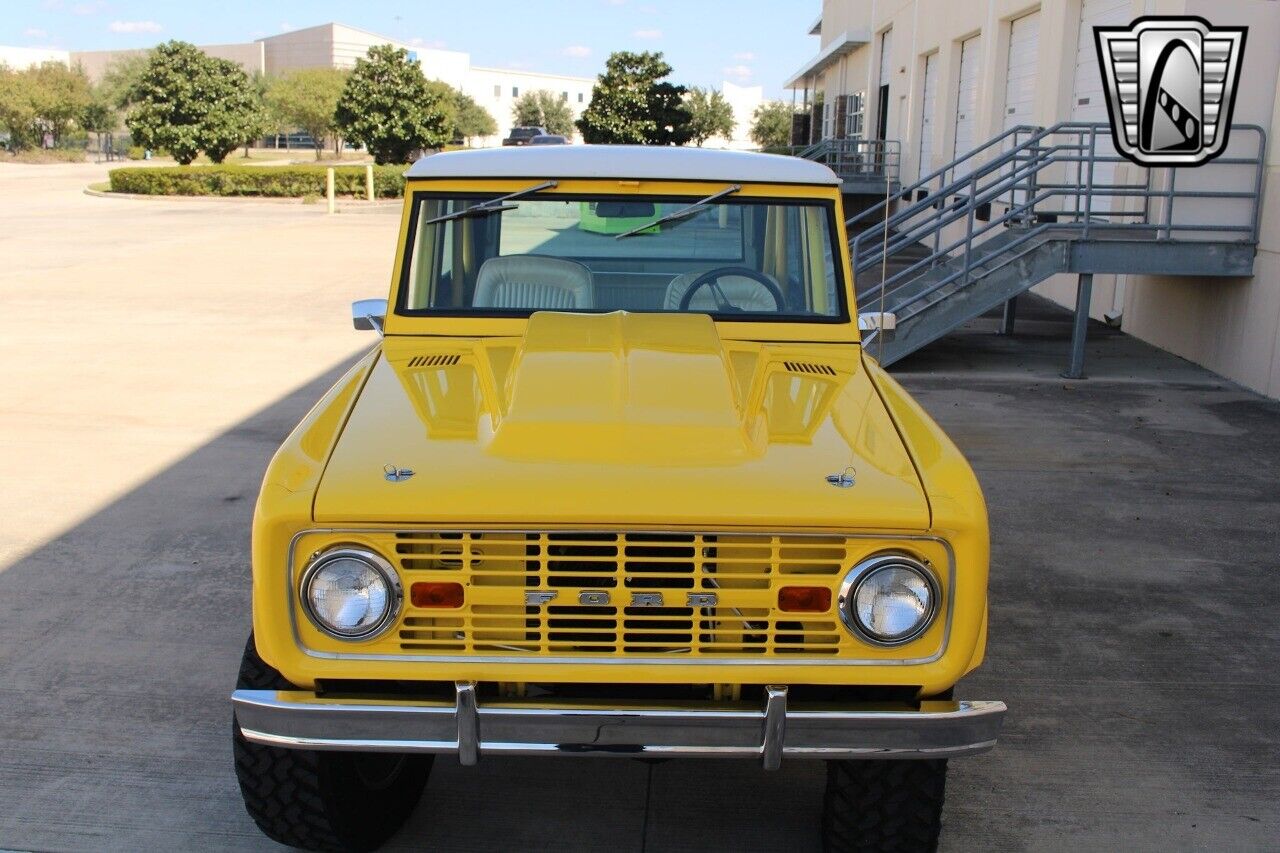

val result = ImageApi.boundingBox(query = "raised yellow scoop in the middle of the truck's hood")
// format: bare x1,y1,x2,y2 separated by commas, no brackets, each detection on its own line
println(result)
488,311,765,466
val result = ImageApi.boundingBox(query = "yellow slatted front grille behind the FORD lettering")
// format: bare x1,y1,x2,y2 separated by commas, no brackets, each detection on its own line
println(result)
394,532,851,657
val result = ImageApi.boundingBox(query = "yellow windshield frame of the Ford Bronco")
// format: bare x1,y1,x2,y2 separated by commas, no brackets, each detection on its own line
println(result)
387,175,860,343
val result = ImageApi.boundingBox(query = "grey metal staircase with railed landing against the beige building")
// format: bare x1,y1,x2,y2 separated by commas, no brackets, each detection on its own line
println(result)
847,122,1266,377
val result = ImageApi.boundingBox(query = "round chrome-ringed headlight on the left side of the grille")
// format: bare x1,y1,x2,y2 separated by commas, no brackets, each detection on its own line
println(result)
301,547,401,639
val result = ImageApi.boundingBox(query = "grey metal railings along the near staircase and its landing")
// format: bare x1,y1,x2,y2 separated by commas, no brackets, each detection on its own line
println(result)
851,122,1266,315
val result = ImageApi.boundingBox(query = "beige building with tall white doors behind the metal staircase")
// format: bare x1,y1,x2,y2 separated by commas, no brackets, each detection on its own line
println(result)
787,0,1280,397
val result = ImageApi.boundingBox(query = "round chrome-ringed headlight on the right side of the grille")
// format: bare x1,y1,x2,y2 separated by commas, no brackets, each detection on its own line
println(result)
840,555,938,646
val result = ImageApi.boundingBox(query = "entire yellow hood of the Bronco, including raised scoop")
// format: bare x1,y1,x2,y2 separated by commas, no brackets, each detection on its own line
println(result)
315,313,929,530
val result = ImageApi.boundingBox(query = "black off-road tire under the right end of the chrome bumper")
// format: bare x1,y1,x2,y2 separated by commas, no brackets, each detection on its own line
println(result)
822,760,947,853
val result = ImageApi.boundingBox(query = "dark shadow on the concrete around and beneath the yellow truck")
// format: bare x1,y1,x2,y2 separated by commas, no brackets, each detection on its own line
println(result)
0,300,1280,853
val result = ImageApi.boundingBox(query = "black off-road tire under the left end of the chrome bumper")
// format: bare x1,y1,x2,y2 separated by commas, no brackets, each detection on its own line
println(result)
232,635,433,850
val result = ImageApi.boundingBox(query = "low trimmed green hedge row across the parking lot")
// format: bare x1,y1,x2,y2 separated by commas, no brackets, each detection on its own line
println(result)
110,164,406,199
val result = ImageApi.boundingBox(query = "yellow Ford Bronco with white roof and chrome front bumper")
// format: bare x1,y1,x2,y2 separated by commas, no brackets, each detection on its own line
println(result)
232,146,1005,850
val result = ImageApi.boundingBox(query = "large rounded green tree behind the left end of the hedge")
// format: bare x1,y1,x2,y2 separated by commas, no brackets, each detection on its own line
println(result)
125,41,264,165
